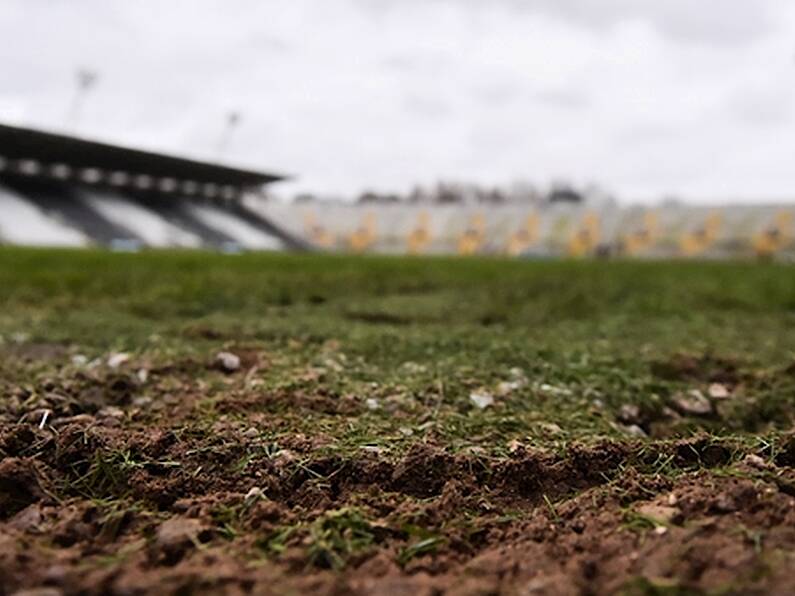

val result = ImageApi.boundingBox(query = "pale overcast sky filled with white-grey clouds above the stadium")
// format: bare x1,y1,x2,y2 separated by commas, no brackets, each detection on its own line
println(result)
0,0,795,201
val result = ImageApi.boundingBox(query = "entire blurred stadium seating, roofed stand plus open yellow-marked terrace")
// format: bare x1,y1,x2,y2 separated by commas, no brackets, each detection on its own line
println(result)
0,125,795,259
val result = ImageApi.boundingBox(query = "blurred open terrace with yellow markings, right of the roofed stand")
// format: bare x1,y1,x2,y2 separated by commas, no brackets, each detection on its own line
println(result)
249,202,795,258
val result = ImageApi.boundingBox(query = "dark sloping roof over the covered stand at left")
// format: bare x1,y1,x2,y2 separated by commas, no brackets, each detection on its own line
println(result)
0,124,284,188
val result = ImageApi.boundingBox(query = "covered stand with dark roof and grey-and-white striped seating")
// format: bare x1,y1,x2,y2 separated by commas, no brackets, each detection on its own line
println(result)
0,125,309,250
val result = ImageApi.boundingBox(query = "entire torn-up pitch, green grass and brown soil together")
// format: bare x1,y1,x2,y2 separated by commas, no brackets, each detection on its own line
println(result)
0,248,795,593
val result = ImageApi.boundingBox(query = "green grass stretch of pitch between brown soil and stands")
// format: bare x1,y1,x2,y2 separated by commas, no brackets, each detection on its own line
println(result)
0,248,795,452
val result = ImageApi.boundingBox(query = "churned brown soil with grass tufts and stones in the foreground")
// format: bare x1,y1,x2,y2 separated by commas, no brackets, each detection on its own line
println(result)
0,355,795,596
